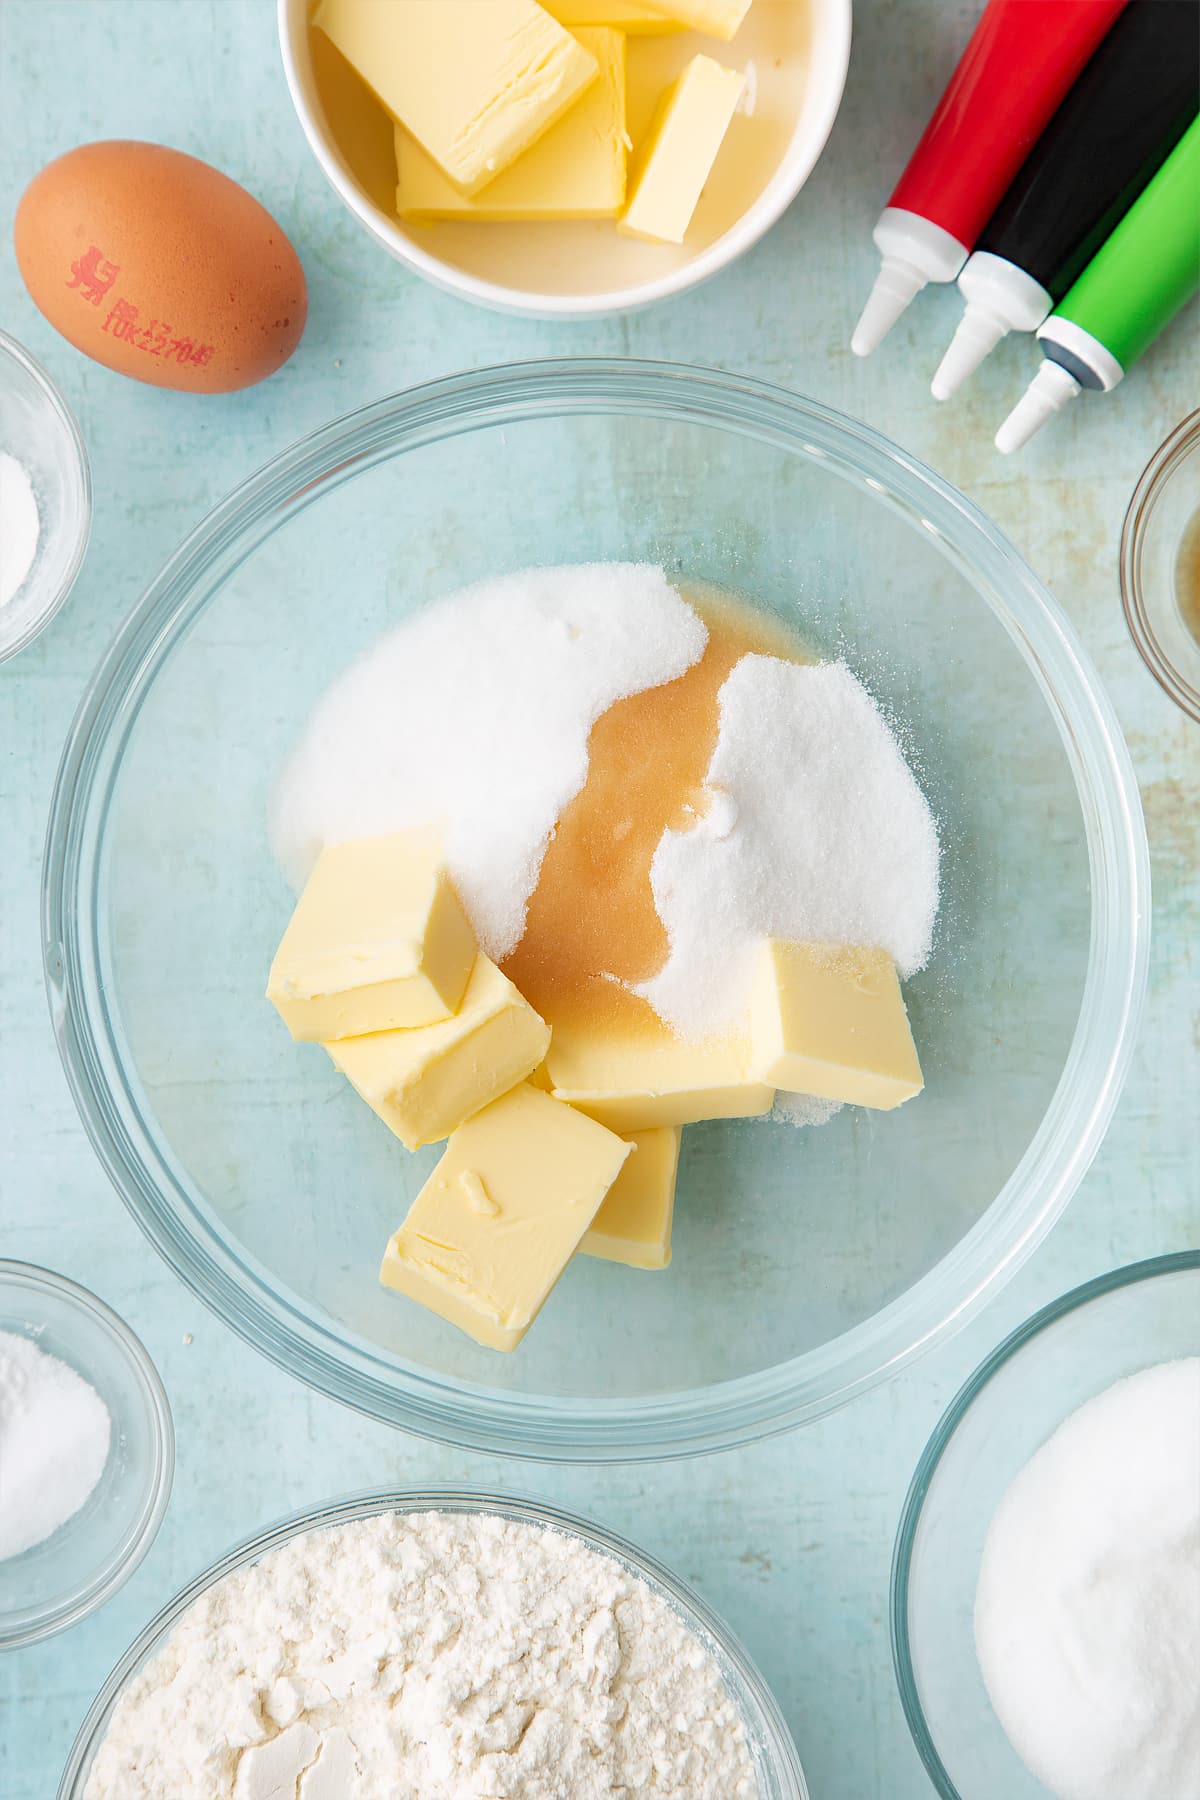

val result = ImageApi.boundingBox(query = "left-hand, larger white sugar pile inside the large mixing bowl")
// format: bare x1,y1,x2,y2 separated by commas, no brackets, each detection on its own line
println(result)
272,563,709,959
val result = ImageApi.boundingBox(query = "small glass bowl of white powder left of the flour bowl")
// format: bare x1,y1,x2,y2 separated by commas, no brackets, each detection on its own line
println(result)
0,1260,175,1651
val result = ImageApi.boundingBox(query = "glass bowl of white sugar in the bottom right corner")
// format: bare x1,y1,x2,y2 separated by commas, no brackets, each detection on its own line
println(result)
892,1251,1200,1800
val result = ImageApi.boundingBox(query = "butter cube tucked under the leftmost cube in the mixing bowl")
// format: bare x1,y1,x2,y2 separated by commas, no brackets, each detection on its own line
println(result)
326,950,551,1150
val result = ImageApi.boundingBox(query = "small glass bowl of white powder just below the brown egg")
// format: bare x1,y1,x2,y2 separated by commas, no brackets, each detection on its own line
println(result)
0,331,92,662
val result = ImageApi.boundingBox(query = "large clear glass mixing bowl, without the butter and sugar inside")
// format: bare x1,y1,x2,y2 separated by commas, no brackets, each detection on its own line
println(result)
45,360,1148,1460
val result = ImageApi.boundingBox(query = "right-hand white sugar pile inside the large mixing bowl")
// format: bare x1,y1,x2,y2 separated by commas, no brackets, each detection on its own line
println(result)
642,655,937,1037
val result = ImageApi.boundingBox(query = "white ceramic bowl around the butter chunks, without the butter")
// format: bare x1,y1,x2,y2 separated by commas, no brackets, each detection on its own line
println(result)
277,0,851,319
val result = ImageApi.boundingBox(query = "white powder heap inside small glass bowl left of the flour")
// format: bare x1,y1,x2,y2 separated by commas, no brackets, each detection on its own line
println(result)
0,1332,112,1561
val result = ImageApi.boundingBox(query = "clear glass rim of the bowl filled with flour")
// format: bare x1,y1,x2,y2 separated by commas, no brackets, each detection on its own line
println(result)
58,1487,808,1800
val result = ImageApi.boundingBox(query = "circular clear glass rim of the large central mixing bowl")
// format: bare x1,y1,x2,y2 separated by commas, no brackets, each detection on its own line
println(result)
41,358,1150,1462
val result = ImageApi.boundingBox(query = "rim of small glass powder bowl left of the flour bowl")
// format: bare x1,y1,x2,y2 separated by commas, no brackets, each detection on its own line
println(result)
0,1256,175,1651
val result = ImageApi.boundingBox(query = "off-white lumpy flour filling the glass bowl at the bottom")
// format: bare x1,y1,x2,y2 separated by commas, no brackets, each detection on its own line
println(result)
86,1512,757,1800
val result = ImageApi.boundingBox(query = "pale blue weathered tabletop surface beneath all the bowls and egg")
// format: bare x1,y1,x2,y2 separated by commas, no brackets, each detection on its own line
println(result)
0,0,1200,1800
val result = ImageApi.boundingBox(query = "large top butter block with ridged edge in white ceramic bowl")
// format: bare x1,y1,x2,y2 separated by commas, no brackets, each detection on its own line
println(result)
313,0,596,194
